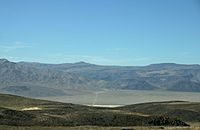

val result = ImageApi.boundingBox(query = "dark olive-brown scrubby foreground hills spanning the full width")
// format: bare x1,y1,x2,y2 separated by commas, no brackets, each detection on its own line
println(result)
0,94,197,127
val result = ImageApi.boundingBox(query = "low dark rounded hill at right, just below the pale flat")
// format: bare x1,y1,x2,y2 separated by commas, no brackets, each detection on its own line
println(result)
120,101,200,122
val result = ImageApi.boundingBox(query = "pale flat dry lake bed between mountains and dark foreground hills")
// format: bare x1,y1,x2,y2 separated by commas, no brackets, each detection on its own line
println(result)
40,90,200,107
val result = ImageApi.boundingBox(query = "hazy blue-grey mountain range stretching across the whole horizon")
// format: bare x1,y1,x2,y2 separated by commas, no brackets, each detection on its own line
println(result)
0,59,200,97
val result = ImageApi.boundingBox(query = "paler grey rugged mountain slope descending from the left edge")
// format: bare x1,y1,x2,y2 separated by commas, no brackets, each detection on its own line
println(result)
0,59,94,96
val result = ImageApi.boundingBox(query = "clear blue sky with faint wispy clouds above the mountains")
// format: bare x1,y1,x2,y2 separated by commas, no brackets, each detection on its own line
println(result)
0,0,200,65
